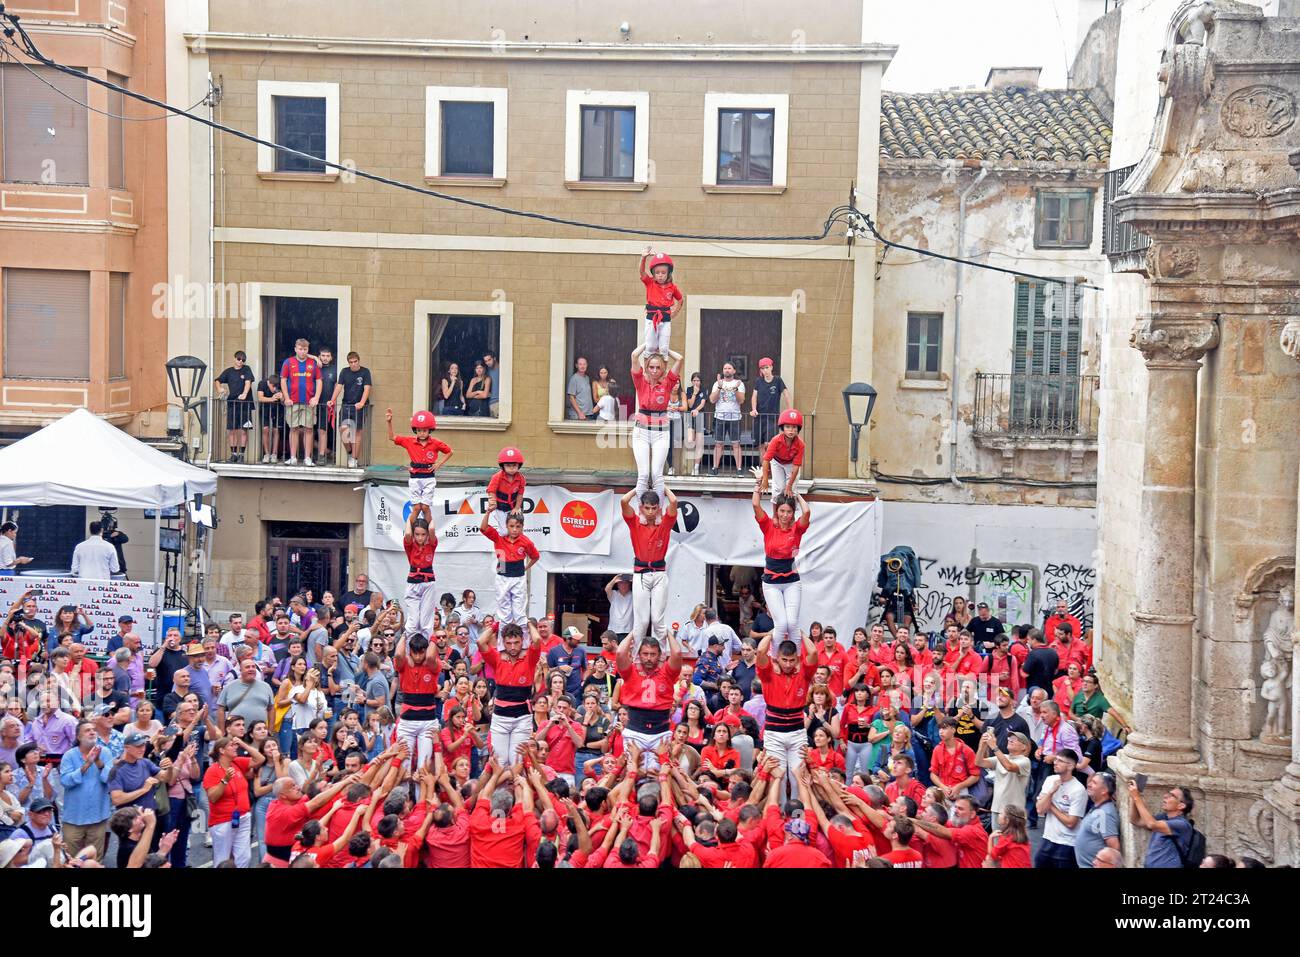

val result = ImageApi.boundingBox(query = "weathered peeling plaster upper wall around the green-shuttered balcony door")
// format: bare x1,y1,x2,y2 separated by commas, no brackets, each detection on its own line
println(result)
871,174,1105,506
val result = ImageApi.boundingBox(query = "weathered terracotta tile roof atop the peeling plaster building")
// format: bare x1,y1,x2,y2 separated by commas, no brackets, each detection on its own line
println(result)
880,87,1110,165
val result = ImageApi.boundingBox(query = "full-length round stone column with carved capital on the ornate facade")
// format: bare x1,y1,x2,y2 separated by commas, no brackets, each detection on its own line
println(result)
1125,313,1218,770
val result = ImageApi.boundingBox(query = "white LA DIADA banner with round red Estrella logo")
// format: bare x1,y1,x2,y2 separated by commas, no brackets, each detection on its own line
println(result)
365,485,621,555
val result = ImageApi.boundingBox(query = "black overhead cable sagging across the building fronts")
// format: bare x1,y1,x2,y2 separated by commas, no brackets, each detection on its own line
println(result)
0,4,1101,289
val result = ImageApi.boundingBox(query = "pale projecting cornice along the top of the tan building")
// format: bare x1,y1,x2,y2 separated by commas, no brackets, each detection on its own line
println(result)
185,33,898,65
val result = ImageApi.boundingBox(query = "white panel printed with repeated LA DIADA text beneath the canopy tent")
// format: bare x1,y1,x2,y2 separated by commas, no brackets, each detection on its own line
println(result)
0,576,163,654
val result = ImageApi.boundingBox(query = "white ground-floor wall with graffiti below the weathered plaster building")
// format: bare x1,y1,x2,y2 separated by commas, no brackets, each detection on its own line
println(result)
881,502,1097,629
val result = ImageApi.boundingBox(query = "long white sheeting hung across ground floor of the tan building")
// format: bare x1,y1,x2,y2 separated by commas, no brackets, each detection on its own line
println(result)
365,486,881,641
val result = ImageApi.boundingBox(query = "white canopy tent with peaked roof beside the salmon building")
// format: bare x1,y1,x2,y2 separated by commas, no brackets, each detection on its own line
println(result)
0,408,217,639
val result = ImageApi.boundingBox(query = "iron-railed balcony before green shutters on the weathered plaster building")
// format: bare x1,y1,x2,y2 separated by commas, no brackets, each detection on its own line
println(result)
971,372,1100,449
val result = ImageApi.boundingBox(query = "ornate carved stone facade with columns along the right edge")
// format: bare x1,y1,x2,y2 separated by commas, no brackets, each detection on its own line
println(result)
1099,0,1300,866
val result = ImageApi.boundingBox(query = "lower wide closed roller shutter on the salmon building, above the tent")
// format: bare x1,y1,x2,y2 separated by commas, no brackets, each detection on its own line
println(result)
4,269,90,380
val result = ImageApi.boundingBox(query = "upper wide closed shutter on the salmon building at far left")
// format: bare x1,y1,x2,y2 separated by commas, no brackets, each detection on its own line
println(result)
0,64,90,186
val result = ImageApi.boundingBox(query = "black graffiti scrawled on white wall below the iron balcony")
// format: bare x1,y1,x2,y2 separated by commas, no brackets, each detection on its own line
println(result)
913,553,1097,631
